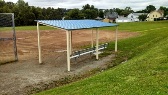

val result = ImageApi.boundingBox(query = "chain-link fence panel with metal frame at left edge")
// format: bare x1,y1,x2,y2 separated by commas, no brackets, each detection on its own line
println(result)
0,13,18,64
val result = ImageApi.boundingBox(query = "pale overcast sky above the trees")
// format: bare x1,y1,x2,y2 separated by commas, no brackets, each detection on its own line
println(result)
5,0,168,11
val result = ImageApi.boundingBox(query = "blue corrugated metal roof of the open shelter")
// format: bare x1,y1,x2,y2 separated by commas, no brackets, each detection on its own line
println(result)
36,20,118,30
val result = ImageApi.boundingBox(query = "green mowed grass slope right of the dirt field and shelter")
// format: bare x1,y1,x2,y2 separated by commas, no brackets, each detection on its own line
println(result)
36,21,168,95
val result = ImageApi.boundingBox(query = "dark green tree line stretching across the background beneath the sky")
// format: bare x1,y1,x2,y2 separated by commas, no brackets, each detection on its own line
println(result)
0,0,168,26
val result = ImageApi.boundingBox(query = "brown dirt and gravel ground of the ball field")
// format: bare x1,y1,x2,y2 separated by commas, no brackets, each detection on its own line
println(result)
0,30,138,95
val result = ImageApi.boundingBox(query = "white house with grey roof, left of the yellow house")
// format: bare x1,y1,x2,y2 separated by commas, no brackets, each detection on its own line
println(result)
127,13,147,22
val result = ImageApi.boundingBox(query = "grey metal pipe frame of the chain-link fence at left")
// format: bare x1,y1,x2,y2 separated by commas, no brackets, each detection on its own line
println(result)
0,13,18,61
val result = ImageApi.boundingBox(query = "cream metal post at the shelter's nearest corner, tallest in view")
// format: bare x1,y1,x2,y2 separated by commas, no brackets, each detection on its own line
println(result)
66,31,70,71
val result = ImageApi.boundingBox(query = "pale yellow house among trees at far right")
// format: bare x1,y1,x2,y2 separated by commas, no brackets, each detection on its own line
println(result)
146,10,164,21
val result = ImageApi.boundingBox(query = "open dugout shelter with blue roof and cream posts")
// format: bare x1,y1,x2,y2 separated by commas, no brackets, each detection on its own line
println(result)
35,20,118,71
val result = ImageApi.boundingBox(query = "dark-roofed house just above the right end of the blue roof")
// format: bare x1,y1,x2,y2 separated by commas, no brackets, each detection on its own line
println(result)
103,12,118,22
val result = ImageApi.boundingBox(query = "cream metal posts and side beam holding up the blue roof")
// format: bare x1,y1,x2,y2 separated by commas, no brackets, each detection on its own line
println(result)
37,22,118,71
